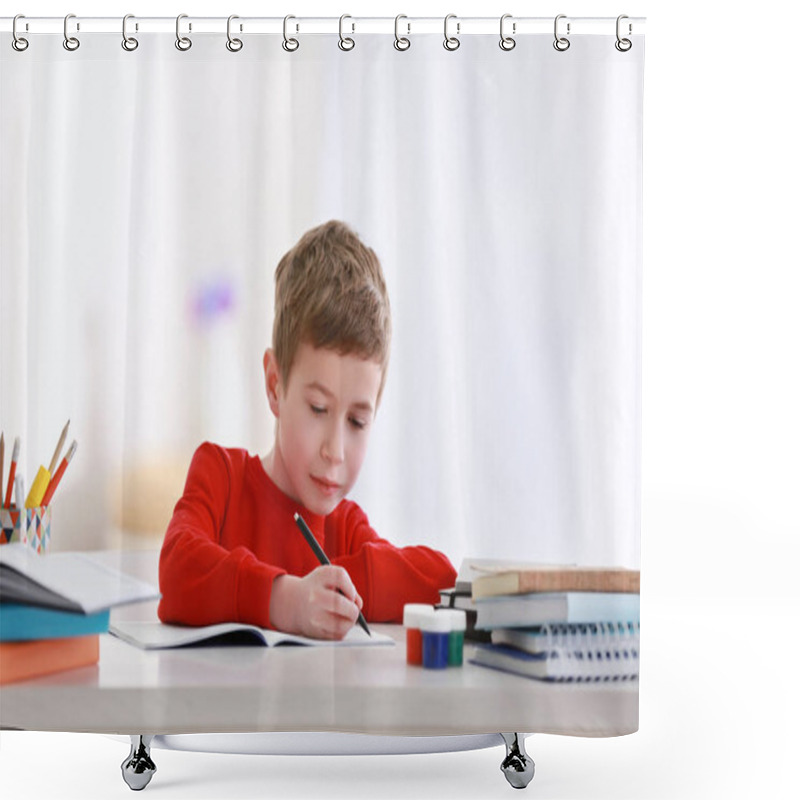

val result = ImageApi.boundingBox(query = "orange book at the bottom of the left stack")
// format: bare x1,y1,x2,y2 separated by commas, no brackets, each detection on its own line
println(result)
0,634,100,685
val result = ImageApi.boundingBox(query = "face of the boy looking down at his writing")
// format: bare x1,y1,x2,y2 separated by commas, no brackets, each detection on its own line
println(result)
264,344,381,514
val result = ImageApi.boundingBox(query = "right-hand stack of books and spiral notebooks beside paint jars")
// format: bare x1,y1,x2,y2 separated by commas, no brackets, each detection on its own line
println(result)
462,565,640,682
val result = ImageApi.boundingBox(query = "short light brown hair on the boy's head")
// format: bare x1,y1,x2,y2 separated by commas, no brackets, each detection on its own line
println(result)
272,220,392,400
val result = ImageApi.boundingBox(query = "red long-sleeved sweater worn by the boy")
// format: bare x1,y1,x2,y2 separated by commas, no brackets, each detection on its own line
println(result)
158,442,456,628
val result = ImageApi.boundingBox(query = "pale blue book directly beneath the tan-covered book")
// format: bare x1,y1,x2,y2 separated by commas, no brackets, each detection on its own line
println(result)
475,592,639,629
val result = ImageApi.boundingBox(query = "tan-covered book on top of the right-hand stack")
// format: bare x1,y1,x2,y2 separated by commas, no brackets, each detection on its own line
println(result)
472,564,639,599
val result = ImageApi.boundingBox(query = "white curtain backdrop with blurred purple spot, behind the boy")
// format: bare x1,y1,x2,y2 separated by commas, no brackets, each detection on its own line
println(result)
0,31,644,567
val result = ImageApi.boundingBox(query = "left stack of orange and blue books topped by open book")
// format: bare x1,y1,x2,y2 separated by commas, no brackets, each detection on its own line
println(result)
0,542,159,684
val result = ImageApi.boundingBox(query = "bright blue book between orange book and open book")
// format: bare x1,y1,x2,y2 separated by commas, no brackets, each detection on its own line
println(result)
0,603,111,642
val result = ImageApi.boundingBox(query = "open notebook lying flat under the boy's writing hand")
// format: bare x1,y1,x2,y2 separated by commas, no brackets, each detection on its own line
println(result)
109,621,394,650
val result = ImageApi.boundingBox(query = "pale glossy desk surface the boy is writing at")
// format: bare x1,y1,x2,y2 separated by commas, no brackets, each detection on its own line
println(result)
0,552,639,736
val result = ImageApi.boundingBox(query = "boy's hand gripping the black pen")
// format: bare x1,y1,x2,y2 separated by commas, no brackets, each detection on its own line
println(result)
270,565,364,639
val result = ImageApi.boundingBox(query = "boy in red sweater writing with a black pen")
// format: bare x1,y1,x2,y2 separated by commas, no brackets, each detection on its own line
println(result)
158,221,456,639
